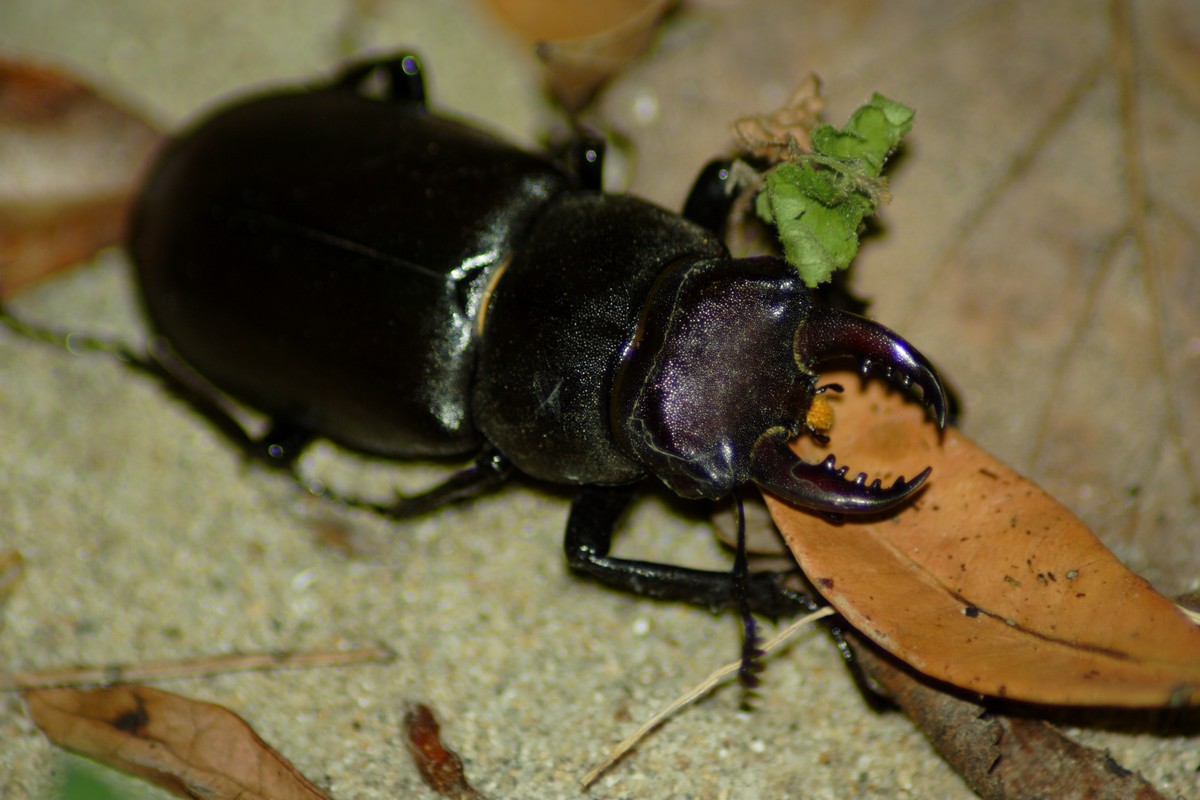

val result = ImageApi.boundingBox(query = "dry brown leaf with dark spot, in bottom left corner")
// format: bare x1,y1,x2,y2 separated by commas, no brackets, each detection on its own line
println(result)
25,686,328,800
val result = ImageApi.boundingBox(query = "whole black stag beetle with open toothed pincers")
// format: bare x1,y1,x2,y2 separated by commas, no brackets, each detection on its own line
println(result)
82,55,947,615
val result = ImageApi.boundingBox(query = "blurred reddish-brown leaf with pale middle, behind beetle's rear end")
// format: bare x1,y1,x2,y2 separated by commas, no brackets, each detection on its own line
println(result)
0,60,160,296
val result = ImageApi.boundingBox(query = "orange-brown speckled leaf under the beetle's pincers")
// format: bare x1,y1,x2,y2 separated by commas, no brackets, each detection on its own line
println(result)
767,374,1200,706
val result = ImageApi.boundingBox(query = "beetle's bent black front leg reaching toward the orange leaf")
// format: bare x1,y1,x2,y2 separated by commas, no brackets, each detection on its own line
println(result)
564,486,812,618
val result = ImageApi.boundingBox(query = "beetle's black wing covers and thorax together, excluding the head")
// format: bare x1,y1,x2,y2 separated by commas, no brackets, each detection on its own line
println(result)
131,76,720,485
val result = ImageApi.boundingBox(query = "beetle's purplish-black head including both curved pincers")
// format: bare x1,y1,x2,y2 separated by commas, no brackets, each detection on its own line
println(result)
612,258,947,515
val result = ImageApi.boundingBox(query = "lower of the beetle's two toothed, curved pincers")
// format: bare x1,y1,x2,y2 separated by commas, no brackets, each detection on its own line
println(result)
750,428,931,515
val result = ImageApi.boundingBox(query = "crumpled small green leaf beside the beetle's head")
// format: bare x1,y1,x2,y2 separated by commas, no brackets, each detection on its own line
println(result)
755,95,914,287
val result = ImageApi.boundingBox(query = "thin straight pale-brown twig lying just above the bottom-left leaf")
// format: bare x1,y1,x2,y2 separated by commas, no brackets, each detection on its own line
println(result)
0,644,396,692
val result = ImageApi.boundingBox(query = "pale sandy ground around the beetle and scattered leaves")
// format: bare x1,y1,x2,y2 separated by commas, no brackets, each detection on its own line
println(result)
0,0,1200,800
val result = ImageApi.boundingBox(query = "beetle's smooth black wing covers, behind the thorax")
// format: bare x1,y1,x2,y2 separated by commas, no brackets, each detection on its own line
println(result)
131,89,570,457
